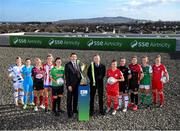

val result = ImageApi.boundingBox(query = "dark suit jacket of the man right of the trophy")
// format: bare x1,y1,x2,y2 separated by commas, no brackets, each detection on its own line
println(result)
87,63,106,86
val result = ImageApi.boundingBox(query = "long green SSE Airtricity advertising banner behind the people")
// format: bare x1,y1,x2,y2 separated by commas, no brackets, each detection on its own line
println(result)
10,36,176,52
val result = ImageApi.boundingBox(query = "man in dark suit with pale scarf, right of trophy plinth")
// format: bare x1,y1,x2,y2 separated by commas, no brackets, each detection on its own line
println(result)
88,54,106,116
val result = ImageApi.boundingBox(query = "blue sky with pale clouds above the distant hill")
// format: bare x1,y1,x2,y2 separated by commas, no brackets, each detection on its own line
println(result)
0,0,180,21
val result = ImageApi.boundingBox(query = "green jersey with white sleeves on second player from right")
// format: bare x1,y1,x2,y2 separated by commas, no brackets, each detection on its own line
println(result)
140,65,152,85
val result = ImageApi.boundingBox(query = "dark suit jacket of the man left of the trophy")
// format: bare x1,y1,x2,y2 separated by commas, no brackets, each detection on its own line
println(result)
65,61,81,88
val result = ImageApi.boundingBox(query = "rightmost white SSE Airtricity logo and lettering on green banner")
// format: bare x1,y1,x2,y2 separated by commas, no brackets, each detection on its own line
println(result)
130,40,170,48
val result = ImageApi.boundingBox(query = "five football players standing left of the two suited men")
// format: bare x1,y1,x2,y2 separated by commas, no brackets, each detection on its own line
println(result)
8,54,64,115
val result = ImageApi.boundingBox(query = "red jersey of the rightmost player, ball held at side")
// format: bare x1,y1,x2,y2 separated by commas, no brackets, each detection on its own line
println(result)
152,64,167,81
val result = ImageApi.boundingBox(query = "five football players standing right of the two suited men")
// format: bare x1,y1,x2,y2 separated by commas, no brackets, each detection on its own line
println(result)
106,55,169,114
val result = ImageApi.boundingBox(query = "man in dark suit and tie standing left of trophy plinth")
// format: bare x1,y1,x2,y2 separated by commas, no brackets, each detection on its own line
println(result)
65,53,81,118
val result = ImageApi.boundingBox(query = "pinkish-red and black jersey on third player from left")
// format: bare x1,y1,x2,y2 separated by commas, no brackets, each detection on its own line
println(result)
32,67,44,82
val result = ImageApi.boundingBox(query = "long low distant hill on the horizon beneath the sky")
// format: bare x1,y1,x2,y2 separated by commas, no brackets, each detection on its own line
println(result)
54,16,146,24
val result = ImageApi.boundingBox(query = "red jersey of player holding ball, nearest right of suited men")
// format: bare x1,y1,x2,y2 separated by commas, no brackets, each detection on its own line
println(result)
106,69,123,92
